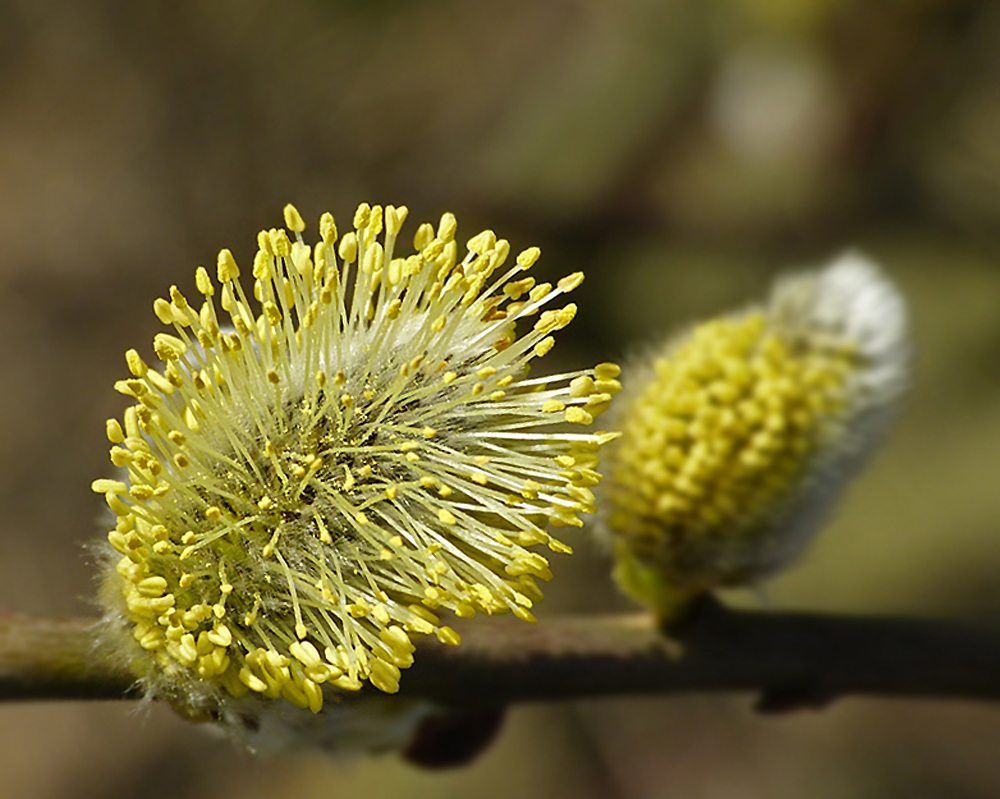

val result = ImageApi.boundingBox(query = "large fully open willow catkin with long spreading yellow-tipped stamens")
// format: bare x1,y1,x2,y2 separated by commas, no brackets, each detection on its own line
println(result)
93,204,618,712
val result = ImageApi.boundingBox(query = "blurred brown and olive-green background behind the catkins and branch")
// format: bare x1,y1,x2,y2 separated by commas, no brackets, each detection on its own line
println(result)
0,0,1000,799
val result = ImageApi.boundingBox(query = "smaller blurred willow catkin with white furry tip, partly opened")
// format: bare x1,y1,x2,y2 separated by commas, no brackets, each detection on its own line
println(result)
602,254,908,615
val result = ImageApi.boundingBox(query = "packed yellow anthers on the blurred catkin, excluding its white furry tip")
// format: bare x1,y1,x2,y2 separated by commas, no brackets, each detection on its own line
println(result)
597,314,851,568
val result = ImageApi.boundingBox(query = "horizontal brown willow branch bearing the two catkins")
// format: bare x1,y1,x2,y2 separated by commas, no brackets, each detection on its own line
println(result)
0,604,1000,710
